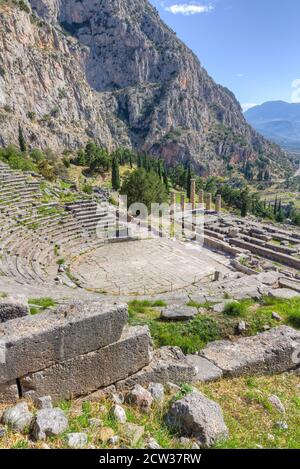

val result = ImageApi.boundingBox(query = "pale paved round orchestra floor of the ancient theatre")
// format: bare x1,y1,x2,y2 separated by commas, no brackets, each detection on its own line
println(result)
71,239,227,295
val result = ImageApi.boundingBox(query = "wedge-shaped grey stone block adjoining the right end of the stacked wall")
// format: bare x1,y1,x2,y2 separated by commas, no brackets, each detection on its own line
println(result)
116,347,196,391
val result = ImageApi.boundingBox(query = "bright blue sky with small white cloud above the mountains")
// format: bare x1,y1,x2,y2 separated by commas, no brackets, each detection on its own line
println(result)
150,0,300,110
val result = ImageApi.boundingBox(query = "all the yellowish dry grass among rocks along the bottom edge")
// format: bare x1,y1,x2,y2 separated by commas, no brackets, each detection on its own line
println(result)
0,374,300,449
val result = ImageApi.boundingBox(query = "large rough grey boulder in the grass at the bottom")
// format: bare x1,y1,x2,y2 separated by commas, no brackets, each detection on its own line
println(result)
166,391,229,448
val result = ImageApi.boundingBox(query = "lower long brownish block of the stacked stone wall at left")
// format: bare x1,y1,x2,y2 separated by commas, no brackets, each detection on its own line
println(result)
20,327,151,402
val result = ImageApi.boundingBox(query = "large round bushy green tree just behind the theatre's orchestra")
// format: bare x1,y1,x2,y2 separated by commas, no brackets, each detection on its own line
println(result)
121,168,168,210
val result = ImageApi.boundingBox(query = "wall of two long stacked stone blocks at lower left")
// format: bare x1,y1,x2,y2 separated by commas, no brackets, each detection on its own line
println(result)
0,302,151,402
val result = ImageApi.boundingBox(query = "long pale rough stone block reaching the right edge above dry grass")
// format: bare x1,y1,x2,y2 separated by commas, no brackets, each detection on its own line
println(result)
199,326,300,376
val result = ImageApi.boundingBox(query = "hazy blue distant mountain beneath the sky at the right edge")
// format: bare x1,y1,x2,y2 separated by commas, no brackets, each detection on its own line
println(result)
245,101,300,152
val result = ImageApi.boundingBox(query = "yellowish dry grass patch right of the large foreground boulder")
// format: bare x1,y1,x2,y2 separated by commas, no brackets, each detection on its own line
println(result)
197,374,300,449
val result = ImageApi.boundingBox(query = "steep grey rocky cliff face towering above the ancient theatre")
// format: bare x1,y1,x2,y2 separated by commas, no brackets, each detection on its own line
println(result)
0,0,284,174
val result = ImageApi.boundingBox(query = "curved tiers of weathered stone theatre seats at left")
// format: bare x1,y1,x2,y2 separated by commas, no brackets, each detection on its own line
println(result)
0,162,108,285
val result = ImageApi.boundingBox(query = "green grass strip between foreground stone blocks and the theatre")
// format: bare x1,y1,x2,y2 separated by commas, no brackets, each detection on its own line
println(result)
129,297,300,353
